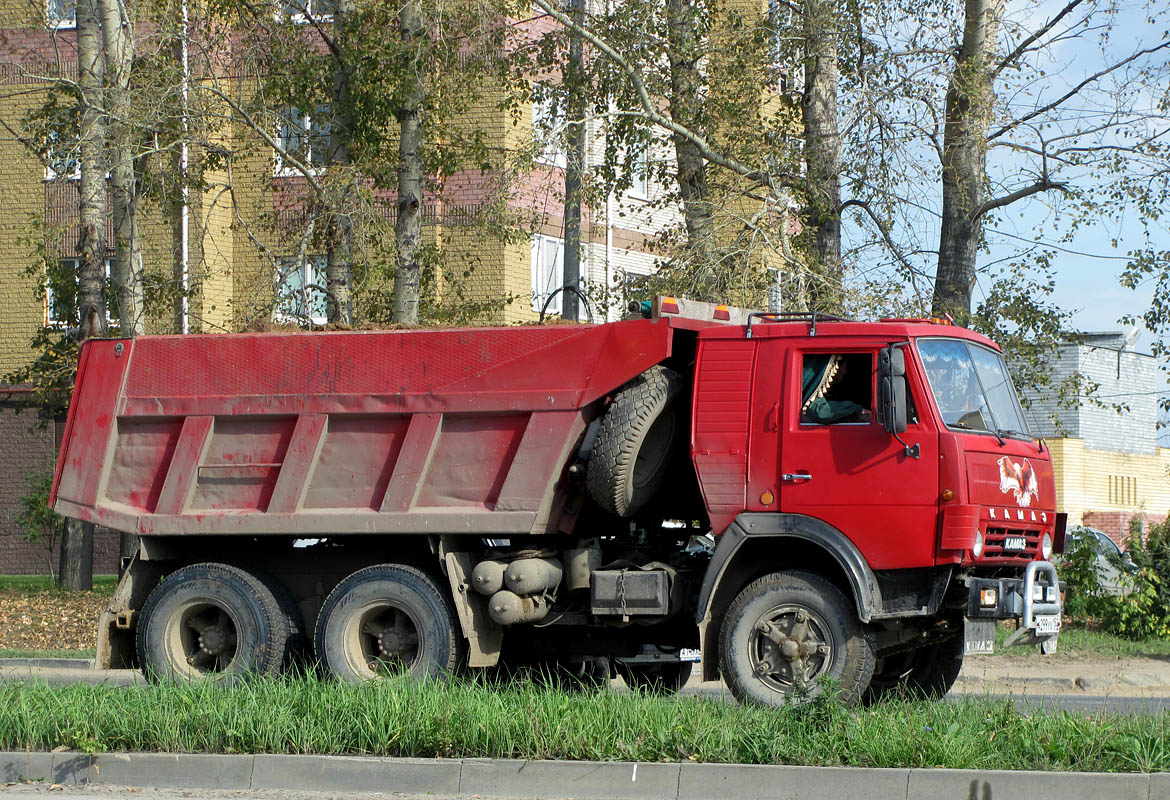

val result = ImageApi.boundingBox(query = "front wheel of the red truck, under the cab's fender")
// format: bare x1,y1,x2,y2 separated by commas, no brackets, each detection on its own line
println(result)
720,571,874,705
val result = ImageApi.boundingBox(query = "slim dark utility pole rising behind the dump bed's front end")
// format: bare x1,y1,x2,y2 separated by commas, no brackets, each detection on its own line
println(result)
560,0,585,319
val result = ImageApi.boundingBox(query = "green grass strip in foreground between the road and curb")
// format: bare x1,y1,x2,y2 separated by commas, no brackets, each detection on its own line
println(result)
0,678,1170,772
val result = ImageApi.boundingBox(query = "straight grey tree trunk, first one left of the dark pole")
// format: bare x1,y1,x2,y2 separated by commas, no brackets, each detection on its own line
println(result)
391,0,426,324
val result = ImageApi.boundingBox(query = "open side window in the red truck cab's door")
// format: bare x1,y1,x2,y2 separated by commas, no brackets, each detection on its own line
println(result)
800,353,874,425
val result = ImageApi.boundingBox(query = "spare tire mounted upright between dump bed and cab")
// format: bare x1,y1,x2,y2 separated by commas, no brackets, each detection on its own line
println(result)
585,366,684,517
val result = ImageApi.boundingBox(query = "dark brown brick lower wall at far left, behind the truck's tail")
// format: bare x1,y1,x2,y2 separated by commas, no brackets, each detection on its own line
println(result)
0,395,118,575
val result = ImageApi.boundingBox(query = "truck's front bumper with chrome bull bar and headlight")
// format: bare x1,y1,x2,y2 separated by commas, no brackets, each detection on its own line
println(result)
966,561,1062,654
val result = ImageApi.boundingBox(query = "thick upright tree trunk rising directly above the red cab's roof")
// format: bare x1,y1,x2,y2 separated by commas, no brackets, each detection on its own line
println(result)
801,0,844,311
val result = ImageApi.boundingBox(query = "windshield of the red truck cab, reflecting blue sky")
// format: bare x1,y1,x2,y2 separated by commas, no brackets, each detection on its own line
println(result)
917,339,1031,437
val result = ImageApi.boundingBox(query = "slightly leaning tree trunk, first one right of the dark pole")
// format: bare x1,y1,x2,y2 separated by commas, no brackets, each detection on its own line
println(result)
666,0,718,284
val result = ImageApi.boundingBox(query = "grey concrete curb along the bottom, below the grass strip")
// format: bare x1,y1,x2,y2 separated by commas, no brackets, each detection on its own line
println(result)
0,751,1170,800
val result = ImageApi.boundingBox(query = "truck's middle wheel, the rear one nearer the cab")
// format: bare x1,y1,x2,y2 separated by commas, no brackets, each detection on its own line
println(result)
315,564,464,683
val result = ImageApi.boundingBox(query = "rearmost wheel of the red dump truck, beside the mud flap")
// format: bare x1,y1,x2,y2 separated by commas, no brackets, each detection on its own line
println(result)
137,563,294,684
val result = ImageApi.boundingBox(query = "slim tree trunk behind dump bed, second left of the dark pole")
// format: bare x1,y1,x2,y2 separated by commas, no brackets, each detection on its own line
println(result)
325,0,357,325
